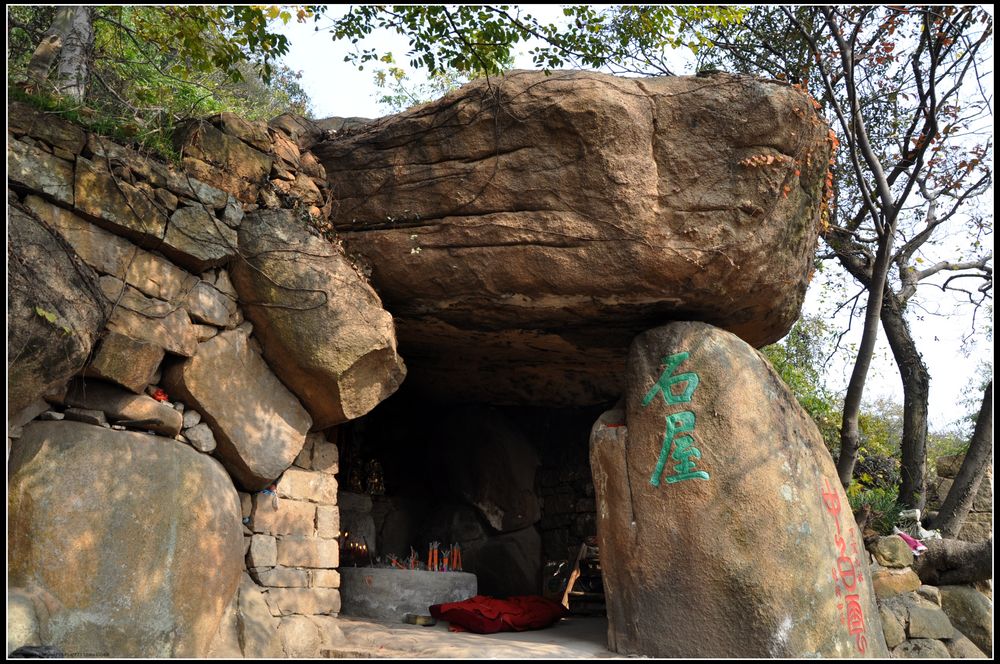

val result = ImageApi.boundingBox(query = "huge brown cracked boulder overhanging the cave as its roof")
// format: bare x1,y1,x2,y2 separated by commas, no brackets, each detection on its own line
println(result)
313,71,829,405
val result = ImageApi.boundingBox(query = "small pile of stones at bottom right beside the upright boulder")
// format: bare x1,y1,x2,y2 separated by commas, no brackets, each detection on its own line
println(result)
870,535,993,658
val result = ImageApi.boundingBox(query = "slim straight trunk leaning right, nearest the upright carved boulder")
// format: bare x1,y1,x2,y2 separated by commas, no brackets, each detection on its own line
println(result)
837,236,896,489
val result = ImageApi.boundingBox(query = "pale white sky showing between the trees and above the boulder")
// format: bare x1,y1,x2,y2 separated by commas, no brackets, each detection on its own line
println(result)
268,5,992,431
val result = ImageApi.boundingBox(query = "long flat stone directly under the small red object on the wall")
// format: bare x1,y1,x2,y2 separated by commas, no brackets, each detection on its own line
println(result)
63,379,184,438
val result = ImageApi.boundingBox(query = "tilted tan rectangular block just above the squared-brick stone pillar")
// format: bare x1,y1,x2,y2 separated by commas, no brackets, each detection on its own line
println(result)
163,329,312,491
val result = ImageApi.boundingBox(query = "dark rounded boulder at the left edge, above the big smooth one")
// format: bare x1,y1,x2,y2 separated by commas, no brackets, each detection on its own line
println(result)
7,200,108,413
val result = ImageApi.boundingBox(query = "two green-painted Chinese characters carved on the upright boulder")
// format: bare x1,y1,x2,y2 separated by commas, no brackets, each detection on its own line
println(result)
642,352,709,486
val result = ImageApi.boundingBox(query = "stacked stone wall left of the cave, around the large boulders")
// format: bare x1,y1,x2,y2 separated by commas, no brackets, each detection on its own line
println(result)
8,103,401,657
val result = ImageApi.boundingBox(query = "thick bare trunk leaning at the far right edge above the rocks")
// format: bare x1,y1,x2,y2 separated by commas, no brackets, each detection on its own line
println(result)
933,381,993,537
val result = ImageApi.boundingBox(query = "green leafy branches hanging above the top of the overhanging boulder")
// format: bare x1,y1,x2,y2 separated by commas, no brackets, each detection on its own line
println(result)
310,5,745,74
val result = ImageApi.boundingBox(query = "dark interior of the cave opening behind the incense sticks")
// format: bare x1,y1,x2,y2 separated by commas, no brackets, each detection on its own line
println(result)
336,381,610,615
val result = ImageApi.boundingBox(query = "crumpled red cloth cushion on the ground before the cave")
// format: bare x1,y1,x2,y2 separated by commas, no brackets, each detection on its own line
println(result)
430,595,569,634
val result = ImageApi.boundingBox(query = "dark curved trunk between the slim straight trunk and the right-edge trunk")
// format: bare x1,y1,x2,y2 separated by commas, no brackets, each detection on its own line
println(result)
882,293,930,510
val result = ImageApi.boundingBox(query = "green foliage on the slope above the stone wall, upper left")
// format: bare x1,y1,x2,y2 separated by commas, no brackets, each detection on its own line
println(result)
7,5,309,156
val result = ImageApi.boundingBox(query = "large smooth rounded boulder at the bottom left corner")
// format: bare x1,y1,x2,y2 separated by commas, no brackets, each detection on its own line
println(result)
8,422,243,657
